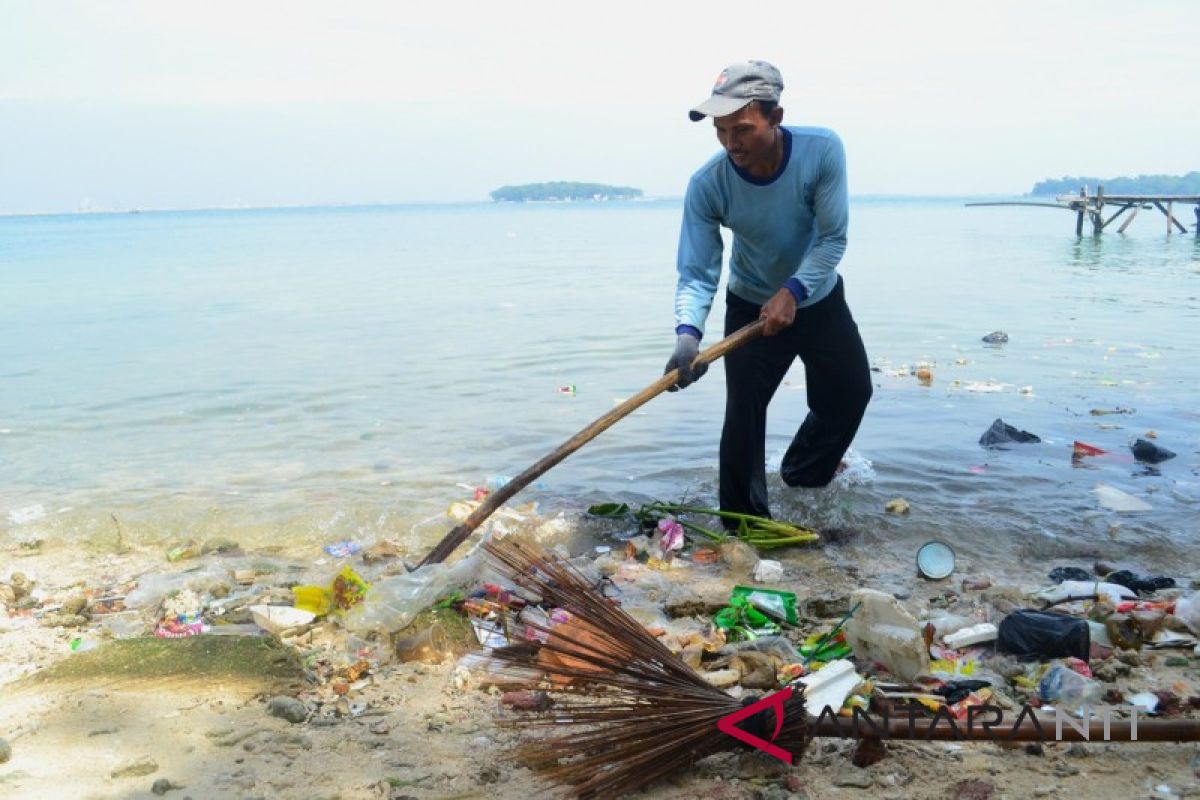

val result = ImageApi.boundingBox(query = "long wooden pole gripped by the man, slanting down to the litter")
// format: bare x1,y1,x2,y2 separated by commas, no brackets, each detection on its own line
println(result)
419,319,766,566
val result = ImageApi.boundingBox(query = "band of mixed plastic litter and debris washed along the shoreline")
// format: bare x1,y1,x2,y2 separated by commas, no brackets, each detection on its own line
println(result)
0,474,1200,796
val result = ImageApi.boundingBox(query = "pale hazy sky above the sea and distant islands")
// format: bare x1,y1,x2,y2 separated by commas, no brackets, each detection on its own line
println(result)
0,0,1200,213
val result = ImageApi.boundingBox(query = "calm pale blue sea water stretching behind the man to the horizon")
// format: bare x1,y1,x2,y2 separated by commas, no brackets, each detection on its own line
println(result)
0,199,1200,575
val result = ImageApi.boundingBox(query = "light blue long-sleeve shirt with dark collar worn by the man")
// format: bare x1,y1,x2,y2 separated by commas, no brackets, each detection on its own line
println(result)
676,127,850,335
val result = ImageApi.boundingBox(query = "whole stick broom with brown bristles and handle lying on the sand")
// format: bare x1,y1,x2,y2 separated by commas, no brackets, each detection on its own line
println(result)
484,537,1200,798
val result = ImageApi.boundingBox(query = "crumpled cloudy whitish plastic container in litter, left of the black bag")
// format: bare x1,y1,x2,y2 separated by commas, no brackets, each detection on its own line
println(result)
846,589,929,680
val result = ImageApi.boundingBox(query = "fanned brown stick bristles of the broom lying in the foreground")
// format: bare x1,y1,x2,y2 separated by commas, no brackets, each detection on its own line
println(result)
484,537,809,798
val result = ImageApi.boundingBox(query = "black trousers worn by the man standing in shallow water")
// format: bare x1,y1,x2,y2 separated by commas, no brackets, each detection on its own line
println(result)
720,277,871,517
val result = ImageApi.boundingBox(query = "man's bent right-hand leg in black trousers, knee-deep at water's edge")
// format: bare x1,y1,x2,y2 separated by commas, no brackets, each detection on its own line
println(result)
779,278,871,487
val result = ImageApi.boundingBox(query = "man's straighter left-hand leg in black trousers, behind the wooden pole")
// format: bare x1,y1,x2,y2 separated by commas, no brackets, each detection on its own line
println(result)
720,294,796,517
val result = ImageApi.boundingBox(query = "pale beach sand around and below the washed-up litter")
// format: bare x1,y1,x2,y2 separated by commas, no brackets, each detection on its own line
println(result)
0,510,1200,799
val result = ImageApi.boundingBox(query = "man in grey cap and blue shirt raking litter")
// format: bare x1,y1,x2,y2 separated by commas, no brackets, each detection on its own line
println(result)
666,61,871,517
